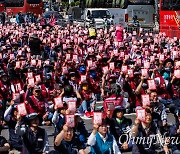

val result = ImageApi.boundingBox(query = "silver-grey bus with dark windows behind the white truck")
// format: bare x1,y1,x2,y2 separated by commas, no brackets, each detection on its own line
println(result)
80,0,155,28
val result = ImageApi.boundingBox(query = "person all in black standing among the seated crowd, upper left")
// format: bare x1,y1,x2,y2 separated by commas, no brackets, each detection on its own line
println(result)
29,34,42,59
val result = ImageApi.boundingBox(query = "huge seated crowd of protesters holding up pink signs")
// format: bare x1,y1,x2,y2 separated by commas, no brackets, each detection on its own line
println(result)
0,17,180,154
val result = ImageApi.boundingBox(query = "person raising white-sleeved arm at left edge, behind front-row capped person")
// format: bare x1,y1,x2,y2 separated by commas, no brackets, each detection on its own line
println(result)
4,100,23,153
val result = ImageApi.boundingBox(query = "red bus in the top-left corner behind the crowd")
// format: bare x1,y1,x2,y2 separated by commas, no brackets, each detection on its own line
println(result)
5,0,44,16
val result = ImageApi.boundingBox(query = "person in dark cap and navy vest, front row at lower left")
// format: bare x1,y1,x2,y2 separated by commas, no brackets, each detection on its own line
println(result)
15,113,49,154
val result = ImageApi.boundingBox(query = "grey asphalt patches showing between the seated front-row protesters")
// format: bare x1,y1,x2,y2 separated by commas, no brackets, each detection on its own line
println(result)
1,102,175,154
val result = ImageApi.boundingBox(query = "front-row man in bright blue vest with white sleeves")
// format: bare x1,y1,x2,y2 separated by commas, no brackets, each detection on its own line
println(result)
87,119,121,154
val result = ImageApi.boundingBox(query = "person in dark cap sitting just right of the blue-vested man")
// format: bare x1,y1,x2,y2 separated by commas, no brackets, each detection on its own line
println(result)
106,106,132,152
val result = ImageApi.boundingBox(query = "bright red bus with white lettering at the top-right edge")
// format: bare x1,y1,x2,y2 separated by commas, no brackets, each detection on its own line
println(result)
159,0,180,38
